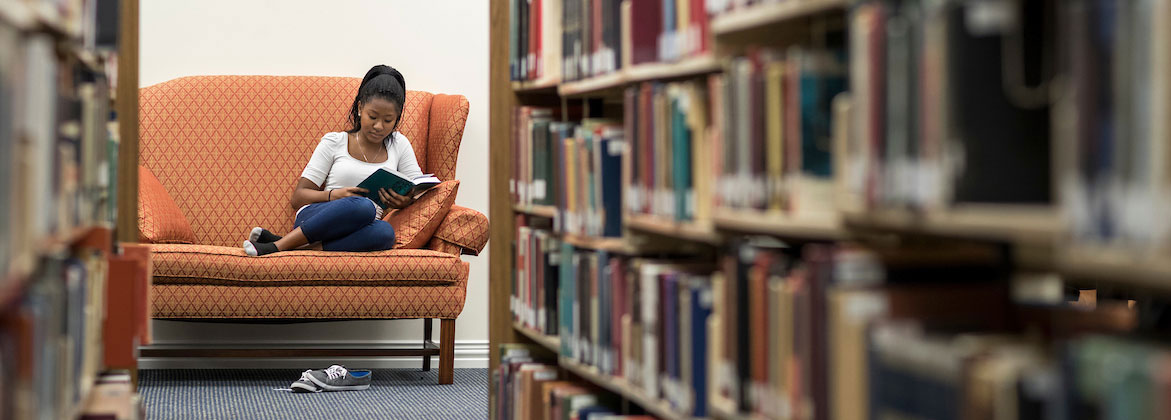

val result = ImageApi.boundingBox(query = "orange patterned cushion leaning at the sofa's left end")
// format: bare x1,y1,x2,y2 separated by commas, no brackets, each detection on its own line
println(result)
138,166,196,243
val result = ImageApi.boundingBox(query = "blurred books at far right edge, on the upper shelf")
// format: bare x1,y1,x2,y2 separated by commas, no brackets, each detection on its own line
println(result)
1055,0,1171,252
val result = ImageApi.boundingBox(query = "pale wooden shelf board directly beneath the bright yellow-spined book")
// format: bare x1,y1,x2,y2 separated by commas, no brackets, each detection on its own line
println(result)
714,208,847,240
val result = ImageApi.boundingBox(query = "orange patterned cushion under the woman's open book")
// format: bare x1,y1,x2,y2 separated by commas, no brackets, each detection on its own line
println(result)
384,180,459,249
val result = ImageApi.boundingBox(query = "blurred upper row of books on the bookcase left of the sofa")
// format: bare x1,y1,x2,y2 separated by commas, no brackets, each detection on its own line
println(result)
0,25,117,279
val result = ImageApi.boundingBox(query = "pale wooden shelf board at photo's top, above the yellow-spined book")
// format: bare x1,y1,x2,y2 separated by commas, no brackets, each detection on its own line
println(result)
712,0,849,36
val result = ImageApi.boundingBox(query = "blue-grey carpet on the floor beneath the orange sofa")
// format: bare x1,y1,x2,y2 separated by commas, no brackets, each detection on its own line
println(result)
139,369,488,420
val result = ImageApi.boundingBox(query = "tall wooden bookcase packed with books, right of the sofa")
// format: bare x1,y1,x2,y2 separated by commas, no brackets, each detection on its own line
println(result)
492,0,1171,420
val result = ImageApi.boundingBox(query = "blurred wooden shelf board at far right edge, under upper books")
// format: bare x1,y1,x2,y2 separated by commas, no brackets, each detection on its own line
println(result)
1056,246,1171,292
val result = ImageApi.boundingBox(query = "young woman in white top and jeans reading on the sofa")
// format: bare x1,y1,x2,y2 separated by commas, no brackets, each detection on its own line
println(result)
244,64,423,256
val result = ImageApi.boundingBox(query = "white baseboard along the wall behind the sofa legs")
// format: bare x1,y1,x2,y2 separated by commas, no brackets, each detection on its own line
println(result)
138,340,488,371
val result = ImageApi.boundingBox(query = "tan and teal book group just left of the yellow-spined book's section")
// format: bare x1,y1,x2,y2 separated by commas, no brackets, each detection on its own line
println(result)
623,81,717,222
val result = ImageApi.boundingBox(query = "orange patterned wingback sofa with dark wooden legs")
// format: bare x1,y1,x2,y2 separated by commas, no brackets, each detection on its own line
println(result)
139,76,488,384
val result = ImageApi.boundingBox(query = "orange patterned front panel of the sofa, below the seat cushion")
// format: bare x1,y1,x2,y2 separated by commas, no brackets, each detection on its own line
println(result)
151,274,467,321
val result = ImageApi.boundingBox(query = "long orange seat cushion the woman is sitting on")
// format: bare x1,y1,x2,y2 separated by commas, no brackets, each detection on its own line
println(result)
151,243,468,287
